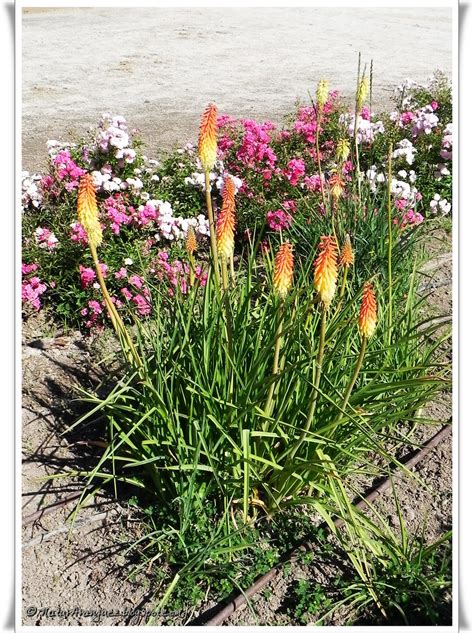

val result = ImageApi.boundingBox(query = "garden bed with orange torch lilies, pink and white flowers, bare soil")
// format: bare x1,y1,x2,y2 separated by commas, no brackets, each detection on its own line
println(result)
22,71,451,624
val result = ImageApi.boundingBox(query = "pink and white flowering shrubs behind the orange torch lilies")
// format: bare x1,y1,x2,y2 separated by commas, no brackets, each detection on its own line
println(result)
22,75,452,327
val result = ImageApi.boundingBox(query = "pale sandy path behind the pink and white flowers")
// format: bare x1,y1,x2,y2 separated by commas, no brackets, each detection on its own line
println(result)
22,7,452,169
